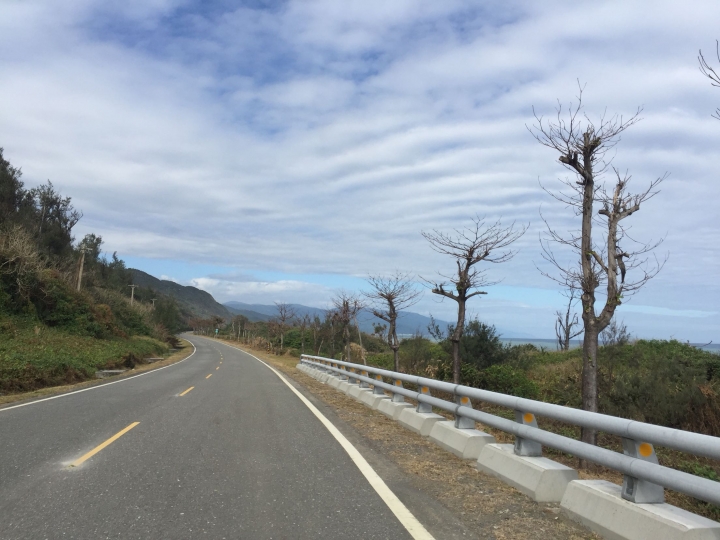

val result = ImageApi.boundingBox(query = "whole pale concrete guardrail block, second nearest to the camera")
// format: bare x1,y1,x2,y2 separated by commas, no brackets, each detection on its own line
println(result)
477,444,578,502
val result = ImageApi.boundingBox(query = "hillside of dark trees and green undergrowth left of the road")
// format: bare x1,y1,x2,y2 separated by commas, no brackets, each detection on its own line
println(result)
0,149,184,392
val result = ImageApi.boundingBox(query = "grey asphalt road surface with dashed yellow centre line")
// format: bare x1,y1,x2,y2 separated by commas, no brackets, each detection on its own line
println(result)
0,337,419,540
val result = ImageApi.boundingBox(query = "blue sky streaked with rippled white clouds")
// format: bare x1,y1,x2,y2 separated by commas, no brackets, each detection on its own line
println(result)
0,0,720,342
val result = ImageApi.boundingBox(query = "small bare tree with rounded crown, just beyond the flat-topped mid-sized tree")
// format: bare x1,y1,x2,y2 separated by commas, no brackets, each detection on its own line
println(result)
365,271,421,371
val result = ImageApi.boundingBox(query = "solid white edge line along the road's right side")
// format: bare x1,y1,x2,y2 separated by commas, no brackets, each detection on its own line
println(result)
208,341,435,540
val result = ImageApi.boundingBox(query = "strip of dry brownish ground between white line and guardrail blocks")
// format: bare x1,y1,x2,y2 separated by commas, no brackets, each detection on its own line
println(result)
228,342,601,540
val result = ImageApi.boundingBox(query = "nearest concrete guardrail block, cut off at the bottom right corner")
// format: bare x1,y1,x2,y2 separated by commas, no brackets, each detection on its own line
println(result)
560,480,720,540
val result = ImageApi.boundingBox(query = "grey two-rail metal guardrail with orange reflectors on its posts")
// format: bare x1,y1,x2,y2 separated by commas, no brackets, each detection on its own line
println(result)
300,355,720,505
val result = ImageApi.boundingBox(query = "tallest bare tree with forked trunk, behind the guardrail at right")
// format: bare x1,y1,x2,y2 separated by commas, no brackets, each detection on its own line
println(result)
528,88,666,444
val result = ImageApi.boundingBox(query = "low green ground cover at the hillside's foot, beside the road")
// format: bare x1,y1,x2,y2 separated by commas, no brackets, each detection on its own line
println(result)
0,327,197,404
